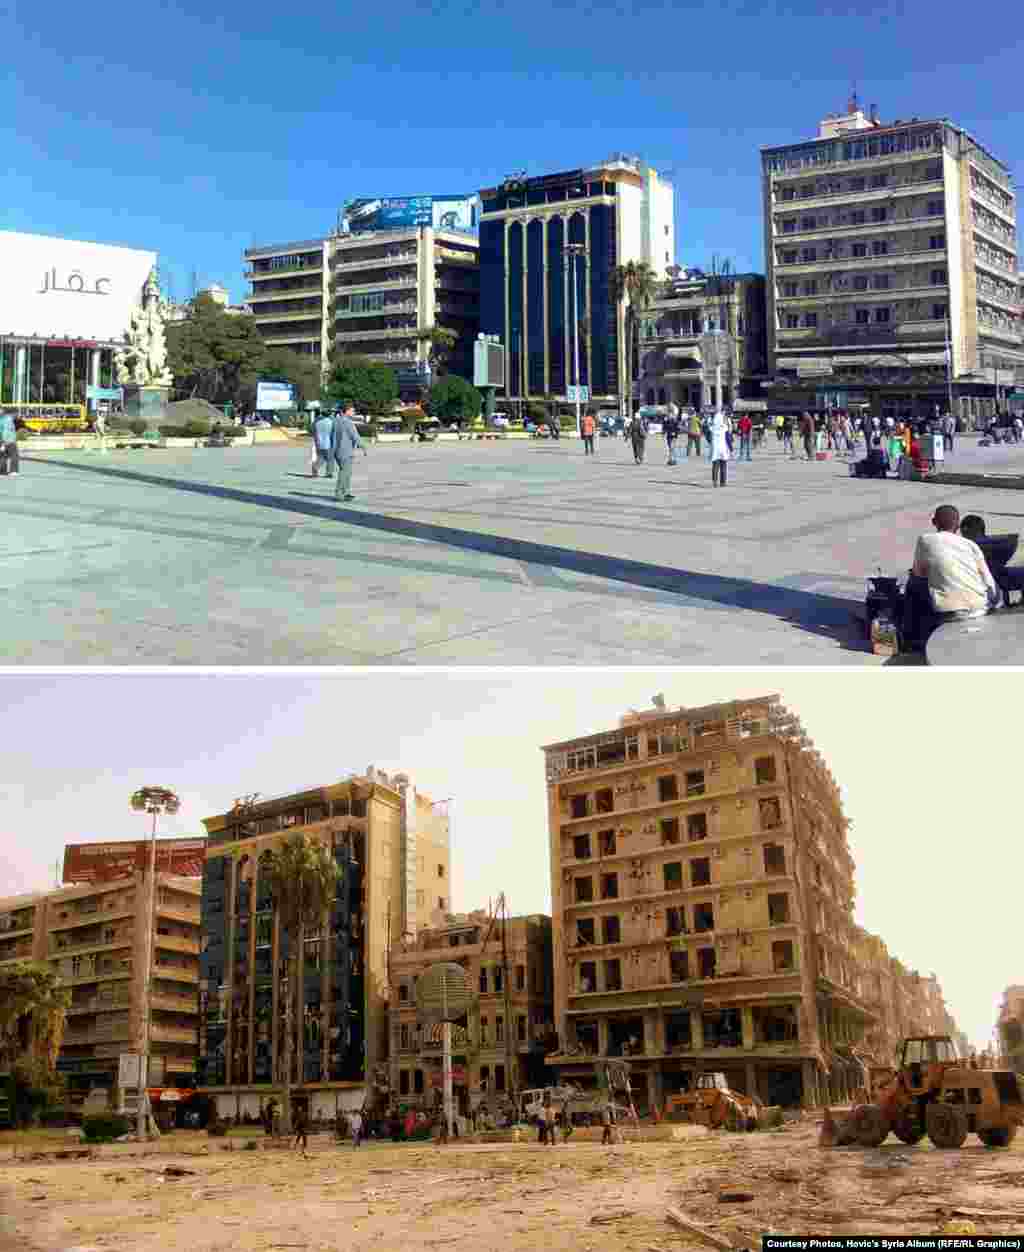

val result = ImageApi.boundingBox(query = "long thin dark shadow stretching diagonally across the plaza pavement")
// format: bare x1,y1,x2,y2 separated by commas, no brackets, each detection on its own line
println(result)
24,457,864,662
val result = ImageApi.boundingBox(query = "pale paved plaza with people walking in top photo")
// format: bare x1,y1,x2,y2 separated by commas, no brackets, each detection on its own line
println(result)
0,437,1024,666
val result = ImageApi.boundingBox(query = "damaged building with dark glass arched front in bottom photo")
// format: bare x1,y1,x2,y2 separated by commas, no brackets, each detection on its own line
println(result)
200,767,451,1116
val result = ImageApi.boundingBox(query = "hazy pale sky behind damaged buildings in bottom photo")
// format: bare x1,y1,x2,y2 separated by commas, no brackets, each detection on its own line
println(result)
0,670,1024,1047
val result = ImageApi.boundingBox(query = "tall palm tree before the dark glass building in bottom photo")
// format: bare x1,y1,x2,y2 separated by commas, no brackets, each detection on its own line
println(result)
267,835,340,1133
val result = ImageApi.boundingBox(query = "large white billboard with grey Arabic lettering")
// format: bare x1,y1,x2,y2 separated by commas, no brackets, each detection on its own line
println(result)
0,230,156,343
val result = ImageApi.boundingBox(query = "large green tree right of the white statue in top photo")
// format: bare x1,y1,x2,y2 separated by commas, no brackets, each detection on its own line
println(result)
166,294,267,404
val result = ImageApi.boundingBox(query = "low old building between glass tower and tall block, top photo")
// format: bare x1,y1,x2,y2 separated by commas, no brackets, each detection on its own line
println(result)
640,269,766,408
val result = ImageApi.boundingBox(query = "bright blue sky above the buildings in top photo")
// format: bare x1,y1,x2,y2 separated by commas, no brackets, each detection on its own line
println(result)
0,0,1024,299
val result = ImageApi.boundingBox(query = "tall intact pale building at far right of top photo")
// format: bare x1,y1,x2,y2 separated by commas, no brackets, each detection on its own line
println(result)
761,100,1024,422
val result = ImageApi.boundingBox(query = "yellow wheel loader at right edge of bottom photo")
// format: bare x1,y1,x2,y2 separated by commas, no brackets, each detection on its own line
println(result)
850,1034,1024,1148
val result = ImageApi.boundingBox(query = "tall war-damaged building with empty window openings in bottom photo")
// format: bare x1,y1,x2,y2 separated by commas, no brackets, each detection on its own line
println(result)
543,696,956,1106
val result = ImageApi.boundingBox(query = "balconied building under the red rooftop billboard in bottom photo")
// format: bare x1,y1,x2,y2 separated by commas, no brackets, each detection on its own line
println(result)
0,861,199,1104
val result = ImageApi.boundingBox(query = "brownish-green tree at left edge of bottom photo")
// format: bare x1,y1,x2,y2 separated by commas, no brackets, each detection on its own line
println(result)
0,960,71,1122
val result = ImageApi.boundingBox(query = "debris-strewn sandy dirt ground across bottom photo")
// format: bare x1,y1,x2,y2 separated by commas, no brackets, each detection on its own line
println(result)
0,1119,1024,1252
